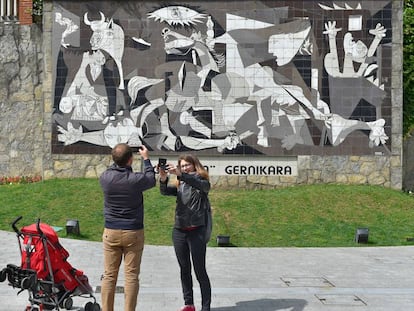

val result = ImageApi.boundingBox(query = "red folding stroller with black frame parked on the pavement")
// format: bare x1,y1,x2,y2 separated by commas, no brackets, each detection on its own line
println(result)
0,216,101,311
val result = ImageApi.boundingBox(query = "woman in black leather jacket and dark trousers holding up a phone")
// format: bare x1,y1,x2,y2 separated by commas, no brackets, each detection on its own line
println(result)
158,155,211,311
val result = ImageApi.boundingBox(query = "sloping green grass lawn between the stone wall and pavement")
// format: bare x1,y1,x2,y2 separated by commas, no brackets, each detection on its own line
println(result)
0,179,414,247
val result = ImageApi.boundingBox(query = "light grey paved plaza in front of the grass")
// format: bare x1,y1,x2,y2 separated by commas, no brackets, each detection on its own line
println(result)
0,231,414,311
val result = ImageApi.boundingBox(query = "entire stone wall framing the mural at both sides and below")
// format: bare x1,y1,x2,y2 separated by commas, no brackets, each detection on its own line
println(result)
0,1,406,189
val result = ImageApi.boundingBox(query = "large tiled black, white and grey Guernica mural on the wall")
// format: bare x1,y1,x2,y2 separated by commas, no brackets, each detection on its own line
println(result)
52,0,392,156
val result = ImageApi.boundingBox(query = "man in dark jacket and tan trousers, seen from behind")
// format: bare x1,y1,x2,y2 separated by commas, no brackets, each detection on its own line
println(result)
99,143,155,311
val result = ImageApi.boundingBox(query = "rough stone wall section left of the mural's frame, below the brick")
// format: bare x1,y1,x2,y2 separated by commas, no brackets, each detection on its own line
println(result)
0,24,45,176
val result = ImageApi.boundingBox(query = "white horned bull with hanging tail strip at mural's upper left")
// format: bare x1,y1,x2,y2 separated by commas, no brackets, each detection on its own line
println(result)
83,12,125,90
